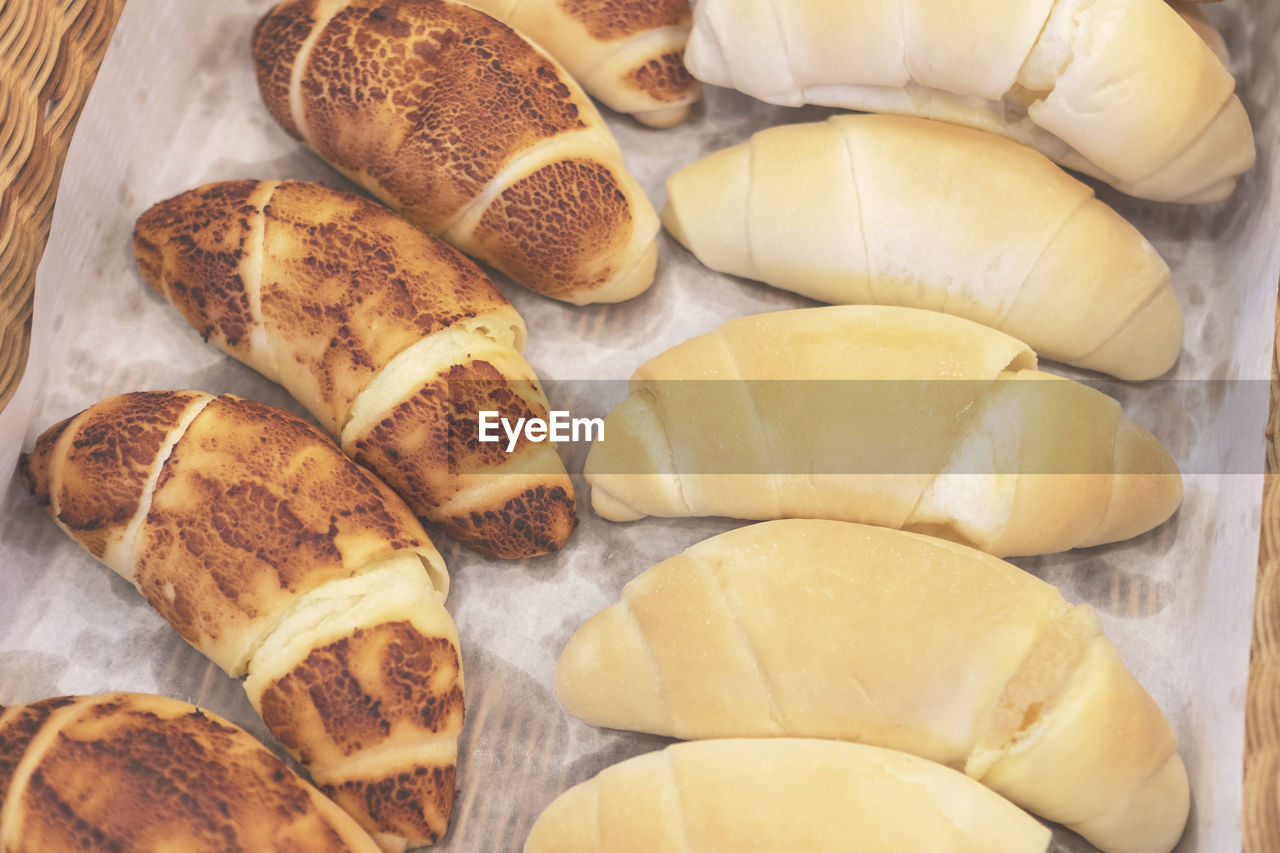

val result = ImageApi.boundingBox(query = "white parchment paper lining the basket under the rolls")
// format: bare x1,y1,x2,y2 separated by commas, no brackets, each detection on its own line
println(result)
0,0,1280,852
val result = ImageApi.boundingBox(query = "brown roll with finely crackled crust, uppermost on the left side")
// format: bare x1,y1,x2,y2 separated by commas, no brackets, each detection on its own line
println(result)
253,0,658,305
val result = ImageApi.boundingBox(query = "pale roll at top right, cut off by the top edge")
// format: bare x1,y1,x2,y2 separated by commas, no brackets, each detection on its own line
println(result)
686,0,1254,202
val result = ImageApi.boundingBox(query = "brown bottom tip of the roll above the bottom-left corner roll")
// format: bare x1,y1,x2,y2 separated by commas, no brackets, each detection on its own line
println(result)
319,762,457,844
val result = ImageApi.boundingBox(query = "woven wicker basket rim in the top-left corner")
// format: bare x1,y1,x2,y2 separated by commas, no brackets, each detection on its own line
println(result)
0,0,124,409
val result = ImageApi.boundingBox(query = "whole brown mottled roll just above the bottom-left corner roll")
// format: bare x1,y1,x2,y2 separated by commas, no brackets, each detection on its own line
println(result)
22,391,462,849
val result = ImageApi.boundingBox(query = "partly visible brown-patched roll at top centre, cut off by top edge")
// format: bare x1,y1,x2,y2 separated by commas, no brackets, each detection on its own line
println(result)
466,0,701,127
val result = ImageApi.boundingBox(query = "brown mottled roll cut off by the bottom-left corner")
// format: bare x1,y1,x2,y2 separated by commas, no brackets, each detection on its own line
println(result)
0,693,378,853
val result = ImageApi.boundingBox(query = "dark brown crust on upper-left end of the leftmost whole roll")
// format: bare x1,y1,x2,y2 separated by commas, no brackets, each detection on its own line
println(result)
28,392,201,558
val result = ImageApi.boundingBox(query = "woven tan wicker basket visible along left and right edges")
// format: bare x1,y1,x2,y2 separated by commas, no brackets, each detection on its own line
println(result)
0,0,1280,853
